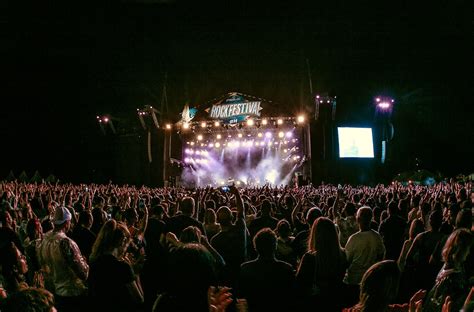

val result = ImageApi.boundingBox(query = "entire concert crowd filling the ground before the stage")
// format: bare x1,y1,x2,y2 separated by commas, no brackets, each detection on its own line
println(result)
0,181,474,312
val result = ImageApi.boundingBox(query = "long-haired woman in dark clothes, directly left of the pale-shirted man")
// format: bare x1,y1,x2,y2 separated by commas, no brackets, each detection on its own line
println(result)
296,217,347,311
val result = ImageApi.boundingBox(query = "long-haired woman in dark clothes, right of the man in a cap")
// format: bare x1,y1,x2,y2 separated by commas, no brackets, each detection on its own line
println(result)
87,220,143,311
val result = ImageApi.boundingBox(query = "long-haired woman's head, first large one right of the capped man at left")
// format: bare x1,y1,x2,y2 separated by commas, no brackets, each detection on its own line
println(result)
89,220,131,262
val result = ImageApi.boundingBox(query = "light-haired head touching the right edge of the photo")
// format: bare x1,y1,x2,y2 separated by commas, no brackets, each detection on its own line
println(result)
443,229,472,266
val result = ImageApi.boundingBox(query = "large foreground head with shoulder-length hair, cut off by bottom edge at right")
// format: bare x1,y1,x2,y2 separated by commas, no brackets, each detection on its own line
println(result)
357,260,400,312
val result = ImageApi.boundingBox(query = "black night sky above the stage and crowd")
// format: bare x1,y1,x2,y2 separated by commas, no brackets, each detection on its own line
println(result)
0,1,474,180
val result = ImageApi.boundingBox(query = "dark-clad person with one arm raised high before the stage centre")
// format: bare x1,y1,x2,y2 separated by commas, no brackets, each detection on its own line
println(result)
211,186,248,287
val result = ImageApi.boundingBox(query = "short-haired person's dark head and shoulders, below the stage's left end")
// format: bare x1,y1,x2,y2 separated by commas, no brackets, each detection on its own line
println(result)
166,197,206,237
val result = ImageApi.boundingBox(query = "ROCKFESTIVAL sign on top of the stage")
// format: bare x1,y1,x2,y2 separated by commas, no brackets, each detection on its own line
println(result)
209,95,262,123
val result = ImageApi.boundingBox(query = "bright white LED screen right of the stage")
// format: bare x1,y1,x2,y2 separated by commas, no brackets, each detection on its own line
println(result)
337,127,374,158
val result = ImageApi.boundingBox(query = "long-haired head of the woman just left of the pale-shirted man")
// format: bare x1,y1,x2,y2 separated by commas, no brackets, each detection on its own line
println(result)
308,217,341,255
